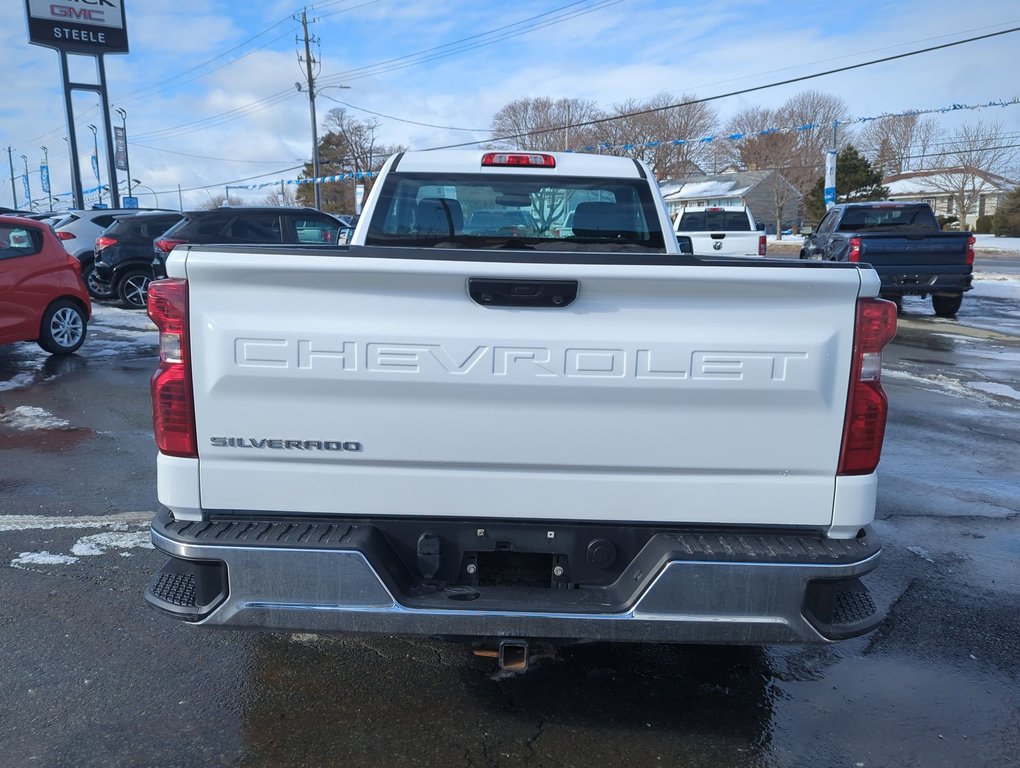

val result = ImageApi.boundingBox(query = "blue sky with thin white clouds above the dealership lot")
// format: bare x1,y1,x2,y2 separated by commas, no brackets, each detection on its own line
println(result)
0,0,1020,207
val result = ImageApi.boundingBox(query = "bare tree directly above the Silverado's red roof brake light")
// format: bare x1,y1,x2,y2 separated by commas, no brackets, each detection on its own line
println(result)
491,96,605,152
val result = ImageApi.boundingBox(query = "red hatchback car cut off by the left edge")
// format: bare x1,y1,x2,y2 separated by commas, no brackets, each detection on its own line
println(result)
0,216,92,355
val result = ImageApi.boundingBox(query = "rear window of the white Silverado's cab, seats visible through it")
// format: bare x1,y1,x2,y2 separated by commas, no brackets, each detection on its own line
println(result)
365,173,665,253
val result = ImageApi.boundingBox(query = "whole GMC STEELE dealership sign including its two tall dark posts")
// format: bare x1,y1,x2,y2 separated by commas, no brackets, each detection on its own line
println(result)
24,0,128,208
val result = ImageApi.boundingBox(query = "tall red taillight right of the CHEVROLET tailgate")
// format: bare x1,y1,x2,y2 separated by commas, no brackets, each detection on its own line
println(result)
837,299,897,474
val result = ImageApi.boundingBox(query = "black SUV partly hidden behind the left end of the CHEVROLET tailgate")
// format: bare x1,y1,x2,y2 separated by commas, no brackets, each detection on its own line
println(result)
152,207,347,279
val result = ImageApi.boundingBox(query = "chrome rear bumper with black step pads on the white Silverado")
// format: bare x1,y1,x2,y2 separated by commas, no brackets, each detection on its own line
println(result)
146,516,881,645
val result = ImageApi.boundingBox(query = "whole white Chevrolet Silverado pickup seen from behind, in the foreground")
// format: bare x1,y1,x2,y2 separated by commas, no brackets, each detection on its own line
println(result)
146,151,896,666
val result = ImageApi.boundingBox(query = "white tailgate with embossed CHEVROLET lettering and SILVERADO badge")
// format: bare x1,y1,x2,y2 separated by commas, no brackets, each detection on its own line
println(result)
183,248,878,526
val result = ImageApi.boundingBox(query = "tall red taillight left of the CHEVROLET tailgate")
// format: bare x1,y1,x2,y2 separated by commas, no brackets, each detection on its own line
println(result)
148,279,198,458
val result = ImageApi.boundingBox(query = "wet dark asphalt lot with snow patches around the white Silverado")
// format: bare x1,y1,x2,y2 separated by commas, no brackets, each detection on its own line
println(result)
0,262,1020,768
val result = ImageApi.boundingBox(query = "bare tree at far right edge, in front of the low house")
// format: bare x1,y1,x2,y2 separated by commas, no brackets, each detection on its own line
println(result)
928,121,1017,226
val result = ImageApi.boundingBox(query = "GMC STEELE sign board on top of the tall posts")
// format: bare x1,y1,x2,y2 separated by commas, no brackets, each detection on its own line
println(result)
24,0,128,56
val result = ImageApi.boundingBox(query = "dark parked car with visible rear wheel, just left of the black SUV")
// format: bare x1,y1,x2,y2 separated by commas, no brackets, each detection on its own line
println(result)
94,211,184,309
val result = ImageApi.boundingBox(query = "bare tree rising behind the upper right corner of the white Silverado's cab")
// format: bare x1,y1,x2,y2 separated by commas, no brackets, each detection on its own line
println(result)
610,93,719,178
